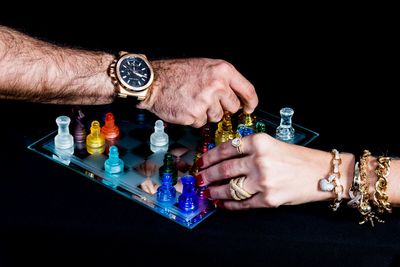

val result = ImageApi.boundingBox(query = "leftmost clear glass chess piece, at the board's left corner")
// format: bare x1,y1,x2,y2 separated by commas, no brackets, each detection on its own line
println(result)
54,116,74,156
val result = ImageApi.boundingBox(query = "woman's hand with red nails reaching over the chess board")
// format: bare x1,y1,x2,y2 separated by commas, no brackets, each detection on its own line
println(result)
196,134,354,210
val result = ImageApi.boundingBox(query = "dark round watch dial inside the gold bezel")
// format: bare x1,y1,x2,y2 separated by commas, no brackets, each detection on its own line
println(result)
119,57,150,88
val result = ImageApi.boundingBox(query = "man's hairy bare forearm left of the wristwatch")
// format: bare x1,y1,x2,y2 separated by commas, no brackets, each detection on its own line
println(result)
0,26,115,105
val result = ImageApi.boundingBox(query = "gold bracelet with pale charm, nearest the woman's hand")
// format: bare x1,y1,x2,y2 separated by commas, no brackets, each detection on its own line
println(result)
319,149,343,211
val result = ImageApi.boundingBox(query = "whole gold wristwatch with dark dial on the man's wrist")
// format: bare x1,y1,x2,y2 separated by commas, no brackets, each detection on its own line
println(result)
109,51,154,100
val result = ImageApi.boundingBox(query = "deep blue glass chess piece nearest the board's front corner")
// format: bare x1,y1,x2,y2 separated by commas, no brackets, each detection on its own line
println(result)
178,175,199,212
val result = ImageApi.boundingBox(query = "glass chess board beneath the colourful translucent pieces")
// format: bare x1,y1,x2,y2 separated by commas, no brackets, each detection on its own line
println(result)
28,110,318,229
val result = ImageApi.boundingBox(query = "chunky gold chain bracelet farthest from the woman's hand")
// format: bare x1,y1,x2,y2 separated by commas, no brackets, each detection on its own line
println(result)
374,157,392,213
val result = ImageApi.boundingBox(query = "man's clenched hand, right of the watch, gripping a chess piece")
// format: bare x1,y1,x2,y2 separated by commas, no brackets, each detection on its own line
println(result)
138,58,258,127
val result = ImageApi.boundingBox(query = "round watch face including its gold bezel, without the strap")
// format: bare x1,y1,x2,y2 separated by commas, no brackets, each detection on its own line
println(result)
117,55,153,91
